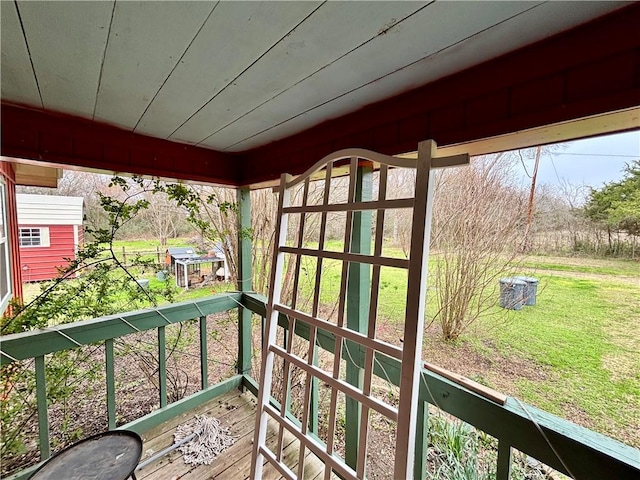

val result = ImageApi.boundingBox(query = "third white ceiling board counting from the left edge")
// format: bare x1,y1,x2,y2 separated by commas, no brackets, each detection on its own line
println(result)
95,2,215,129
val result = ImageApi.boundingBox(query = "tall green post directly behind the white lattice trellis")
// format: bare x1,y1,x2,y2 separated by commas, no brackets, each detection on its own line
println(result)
345,166,373,469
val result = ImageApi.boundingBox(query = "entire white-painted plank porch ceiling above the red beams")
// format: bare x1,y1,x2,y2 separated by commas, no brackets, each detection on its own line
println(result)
1,1,628,151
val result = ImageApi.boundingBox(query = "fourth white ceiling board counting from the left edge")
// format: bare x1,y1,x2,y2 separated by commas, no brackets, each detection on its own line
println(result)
136,2,320,138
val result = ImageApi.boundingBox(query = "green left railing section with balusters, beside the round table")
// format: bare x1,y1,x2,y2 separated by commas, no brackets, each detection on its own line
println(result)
0,292,242,480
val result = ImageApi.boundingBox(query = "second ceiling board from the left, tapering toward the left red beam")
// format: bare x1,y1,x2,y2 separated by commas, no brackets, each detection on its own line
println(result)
18,2,113,118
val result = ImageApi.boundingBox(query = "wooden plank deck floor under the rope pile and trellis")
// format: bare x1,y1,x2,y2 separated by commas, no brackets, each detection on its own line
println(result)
136,391,324,480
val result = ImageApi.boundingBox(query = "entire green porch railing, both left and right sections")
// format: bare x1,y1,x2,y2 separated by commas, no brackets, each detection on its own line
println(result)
0,293,640,480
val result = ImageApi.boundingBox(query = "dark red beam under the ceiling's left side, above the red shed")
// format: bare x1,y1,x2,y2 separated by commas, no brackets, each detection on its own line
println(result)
2,103,240,185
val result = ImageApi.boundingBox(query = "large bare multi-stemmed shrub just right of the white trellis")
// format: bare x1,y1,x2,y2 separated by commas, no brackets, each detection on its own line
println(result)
431,154,526,340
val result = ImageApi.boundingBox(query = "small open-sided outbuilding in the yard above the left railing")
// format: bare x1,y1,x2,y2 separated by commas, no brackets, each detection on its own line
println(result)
165,247,229,289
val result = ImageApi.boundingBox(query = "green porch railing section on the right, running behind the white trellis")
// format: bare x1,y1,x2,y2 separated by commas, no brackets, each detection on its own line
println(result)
242,293,640,480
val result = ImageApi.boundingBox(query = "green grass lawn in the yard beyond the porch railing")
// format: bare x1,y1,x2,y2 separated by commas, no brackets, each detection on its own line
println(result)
17,239,640,446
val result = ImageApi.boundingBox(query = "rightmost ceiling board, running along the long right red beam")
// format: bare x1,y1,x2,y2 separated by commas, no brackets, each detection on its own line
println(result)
228,2,626,151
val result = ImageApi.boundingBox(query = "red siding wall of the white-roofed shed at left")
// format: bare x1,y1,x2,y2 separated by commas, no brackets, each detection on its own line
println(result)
20,225,75,282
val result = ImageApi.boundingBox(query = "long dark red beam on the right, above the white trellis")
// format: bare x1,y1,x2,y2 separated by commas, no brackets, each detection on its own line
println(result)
241,4,640,184
